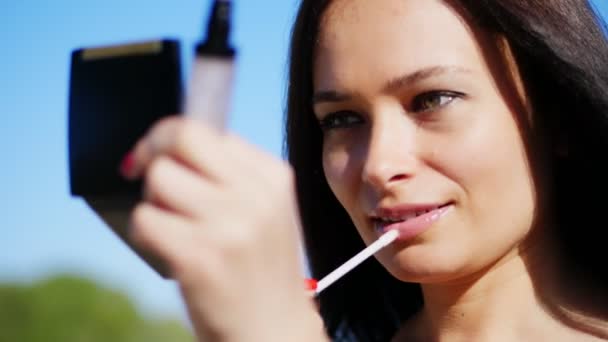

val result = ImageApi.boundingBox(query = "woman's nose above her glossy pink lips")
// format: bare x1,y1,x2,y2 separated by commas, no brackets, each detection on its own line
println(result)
362,114,418,192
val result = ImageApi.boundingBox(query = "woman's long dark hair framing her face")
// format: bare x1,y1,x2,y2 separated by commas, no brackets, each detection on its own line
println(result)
285,0,608,341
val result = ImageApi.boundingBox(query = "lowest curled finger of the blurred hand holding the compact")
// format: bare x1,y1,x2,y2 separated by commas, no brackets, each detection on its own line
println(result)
129,202,204,276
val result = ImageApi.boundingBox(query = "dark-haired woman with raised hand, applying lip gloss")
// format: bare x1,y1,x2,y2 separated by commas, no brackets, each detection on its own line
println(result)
123,0,608,341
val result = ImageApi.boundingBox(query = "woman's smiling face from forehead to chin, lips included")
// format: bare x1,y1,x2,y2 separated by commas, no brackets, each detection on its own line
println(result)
313,0,536,282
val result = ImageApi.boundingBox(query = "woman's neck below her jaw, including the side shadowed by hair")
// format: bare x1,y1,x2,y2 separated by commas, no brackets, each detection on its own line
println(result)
418,230,588,341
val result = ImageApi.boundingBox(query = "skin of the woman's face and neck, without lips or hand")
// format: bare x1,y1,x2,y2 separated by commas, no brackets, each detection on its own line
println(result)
314,0,608,341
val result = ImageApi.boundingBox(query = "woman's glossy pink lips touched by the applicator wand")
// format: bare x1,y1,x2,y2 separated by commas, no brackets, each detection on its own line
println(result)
371,202,453,240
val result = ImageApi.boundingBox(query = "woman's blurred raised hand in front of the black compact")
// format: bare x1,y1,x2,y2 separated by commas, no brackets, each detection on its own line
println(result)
123,117,325,341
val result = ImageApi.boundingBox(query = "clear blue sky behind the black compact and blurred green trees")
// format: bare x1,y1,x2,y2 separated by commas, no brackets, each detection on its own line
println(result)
0,0,608,326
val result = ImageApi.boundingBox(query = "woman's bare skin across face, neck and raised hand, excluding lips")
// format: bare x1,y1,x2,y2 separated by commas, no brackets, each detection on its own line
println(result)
121,0,608,342
